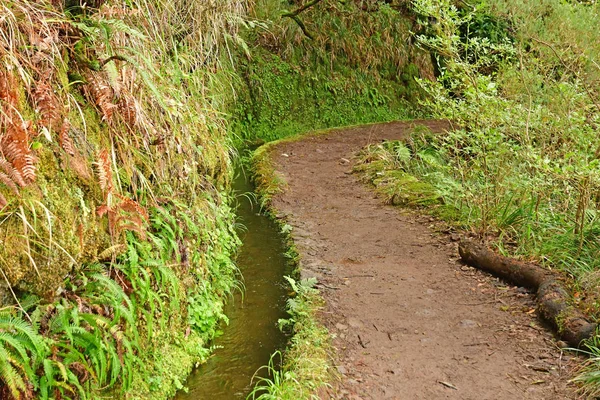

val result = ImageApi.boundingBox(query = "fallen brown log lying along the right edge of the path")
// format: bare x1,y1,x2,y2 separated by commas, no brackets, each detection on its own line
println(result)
458,240,597,347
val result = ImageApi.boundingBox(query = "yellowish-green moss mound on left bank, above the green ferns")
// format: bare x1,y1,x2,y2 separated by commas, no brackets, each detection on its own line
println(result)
0,130,111,298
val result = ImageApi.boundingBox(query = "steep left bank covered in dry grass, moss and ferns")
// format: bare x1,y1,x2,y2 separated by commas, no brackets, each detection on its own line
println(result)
0,0,245,400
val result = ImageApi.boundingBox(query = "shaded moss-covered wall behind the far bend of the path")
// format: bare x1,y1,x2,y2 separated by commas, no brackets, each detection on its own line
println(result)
232,0,433,141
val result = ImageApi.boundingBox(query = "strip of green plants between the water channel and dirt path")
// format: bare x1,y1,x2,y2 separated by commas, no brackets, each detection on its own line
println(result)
248,146,333,400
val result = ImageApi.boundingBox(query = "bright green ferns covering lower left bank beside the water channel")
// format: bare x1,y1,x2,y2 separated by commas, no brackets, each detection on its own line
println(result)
0,171,239,399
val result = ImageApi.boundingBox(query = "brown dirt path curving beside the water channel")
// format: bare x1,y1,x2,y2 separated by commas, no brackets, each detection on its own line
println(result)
272,122,576,400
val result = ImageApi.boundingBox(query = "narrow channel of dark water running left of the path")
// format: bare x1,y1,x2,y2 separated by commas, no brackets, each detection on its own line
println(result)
175,170,289,400
